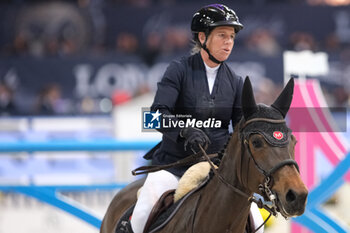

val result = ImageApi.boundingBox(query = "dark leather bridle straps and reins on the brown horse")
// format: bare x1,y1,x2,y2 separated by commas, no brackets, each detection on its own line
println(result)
199,118,299,232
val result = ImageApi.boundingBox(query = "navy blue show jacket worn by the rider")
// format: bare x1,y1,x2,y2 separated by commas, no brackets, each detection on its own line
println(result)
151,53,243,176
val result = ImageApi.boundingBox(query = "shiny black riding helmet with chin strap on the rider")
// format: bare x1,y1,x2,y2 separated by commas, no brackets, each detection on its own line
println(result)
191,4,243,64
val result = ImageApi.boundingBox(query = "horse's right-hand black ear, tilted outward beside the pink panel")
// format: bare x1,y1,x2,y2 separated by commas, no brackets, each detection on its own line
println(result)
271,78,294,118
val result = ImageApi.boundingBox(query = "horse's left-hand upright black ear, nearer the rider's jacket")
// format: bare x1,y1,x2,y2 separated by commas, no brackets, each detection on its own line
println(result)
242,76,257,120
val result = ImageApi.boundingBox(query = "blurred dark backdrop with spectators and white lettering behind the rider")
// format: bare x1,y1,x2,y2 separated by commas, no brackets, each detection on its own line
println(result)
0,0,350,114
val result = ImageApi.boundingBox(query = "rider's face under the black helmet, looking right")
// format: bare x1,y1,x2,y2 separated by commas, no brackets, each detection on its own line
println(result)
202,26,236,61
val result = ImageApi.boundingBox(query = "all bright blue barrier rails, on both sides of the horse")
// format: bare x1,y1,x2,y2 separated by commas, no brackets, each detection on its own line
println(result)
0,139,350,230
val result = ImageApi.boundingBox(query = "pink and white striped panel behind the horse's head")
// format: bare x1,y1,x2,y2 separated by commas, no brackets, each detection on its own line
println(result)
288,79,350,233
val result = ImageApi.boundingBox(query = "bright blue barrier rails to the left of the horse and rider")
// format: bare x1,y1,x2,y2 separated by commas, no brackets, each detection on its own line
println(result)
0,139,158,228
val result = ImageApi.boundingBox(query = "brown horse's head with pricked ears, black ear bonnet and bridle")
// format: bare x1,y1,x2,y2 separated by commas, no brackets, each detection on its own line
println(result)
239,77,308,217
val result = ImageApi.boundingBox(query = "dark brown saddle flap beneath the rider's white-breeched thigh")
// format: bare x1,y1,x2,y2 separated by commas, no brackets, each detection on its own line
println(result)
143,189,175,233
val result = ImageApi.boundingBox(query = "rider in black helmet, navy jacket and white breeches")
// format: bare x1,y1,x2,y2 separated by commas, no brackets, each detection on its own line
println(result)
131,4,261,233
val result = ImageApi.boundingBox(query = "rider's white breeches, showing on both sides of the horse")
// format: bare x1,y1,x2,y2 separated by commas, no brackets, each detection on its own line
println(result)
130,170,264,233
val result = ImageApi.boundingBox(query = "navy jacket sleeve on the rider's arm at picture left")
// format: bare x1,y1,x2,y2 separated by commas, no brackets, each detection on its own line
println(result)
151,62,185,142
